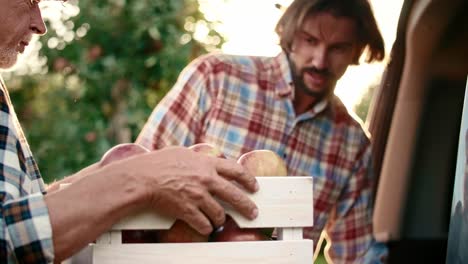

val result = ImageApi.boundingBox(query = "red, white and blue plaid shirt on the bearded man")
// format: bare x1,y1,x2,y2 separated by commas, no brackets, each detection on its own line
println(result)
137,53,385,263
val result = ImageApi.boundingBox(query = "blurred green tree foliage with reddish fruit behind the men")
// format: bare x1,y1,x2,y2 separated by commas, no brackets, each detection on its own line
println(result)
8,0,223,182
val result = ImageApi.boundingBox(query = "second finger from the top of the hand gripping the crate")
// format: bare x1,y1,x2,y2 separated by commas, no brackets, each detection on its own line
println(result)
211,179,258,219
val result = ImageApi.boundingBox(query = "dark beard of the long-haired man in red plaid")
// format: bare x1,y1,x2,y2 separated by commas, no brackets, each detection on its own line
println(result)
290,61,335,100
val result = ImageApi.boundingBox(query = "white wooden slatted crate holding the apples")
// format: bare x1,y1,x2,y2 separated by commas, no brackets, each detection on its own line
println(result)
92,176,313,264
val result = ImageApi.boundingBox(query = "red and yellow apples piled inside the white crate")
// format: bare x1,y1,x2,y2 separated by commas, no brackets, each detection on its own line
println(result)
100,143,287,244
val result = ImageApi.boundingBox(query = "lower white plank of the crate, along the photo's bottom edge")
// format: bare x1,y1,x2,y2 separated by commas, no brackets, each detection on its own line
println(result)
93,240,313,264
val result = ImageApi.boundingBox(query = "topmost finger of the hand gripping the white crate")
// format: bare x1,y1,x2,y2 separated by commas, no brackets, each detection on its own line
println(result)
215,158,258,192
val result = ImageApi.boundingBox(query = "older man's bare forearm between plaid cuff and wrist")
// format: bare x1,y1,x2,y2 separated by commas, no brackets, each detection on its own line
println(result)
45,167,142,260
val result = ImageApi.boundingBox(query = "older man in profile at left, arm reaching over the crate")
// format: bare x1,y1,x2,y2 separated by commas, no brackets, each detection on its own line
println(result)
0,0,258,263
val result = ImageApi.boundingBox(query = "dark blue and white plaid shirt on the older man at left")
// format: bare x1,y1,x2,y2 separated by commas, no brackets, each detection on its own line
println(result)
0,78,53,263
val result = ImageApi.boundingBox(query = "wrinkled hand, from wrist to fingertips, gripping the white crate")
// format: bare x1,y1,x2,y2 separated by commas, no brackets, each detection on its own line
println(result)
126,147,258,234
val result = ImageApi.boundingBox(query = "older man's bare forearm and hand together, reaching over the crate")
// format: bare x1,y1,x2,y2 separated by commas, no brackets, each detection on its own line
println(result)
45,147,258,261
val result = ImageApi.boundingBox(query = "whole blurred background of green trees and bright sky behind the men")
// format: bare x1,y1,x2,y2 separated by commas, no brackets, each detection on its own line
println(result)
2,0,402,188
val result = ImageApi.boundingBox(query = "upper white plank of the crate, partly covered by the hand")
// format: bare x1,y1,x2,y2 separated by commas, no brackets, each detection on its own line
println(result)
112,176,314,230
